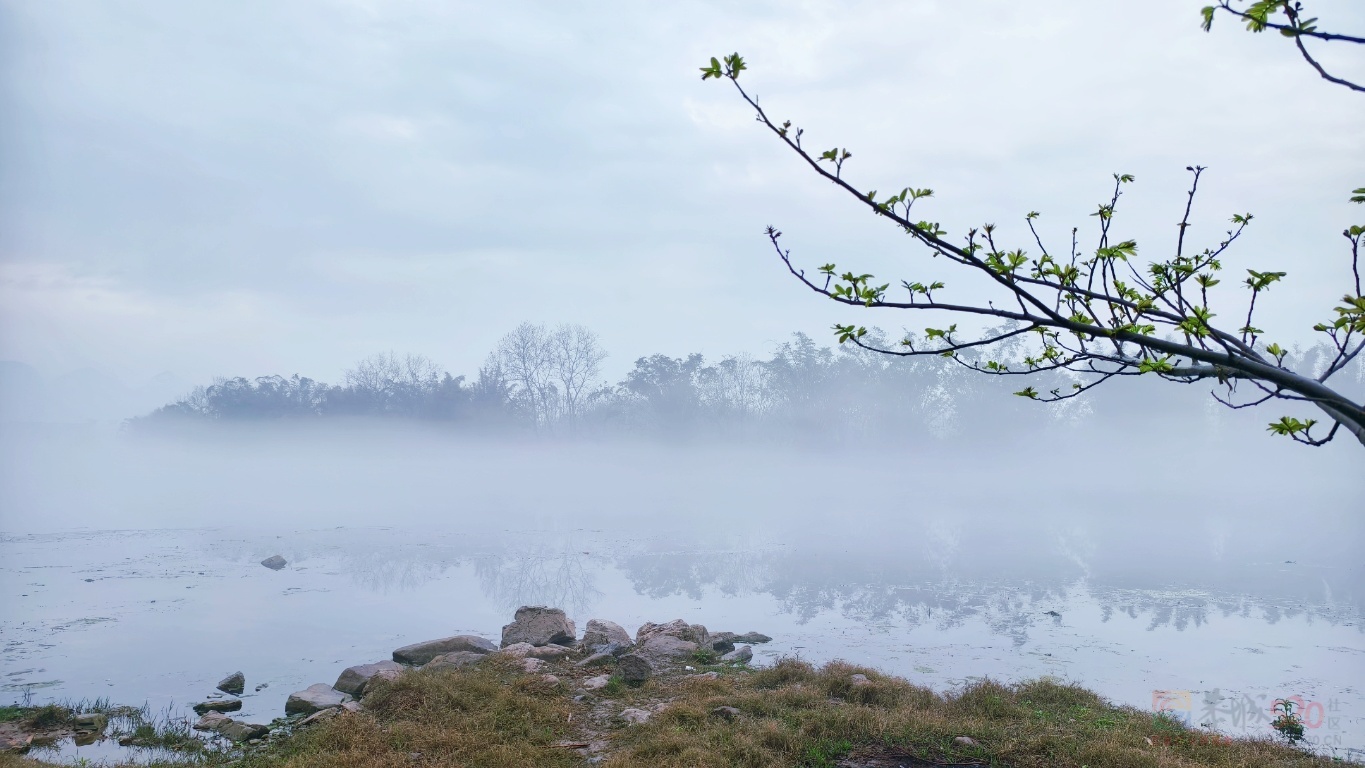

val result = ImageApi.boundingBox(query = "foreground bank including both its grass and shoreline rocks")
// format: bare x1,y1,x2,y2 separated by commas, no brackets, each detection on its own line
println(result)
0,608,1345,768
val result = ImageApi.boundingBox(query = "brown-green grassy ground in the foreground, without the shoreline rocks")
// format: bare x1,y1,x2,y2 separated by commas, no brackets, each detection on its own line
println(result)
0,658,1343,768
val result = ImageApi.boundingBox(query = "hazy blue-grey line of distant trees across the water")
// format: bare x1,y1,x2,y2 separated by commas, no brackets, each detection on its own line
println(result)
130,323,1365,442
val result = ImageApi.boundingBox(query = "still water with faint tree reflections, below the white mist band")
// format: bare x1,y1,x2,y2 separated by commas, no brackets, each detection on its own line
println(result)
0,521,1365,752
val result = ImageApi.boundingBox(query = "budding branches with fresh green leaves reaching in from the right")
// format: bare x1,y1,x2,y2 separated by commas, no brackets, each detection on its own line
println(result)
702,0,1365,445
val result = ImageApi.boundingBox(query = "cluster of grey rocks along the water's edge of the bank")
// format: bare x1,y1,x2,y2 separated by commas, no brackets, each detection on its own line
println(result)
194,606,773,741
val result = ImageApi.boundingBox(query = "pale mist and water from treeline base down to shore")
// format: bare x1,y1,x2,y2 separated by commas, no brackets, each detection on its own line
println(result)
0,423,1365,749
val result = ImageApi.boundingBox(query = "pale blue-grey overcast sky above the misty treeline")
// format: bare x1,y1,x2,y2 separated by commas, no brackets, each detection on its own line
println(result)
0,0,1365,383
